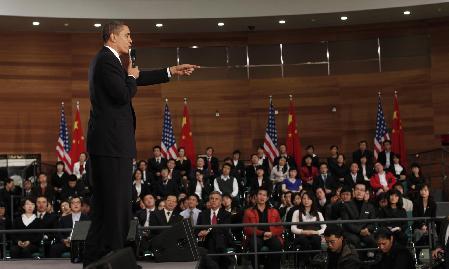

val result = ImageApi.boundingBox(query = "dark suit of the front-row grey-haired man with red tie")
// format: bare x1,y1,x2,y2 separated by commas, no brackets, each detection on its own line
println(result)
195,208,232,253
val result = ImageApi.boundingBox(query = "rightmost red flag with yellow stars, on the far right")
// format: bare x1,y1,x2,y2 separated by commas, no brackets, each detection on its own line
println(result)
391,92,408,167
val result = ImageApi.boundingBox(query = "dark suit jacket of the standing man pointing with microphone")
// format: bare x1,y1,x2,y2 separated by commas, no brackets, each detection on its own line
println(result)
87,47,169,158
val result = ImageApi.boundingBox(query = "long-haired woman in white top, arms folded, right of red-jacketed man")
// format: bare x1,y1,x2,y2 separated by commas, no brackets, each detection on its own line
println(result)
291,192,326,265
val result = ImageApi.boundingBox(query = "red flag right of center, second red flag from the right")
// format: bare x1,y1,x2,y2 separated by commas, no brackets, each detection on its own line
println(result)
285,95,302,168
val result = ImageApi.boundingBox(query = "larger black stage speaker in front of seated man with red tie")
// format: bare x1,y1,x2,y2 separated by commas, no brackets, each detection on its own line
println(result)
151,219,199,262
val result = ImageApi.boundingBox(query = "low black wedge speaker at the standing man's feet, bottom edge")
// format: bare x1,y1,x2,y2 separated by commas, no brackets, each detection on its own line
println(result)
85,247,137,269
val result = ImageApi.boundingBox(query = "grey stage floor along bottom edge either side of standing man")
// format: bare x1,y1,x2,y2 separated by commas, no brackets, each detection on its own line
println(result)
0,260,197,269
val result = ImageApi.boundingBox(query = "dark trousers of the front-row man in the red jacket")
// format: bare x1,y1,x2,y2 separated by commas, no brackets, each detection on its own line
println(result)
249,237,282,269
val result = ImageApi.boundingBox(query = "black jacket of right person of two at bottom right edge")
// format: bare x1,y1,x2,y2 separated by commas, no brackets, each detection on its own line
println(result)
371,243,415,269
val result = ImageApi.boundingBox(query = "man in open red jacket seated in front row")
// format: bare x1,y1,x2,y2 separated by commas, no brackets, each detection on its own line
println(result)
243,188,284,269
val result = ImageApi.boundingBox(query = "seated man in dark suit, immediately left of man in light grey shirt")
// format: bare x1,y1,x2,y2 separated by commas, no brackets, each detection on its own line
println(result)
150,194,183,236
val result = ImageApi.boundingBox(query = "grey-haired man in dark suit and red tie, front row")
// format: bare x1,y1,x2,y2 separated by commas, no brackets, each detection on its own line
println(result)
196,191,233,269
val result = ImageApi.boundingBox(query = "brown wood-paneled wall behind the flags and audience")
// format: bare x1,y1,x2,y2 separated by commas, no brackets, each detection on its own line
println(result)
0,20,449,163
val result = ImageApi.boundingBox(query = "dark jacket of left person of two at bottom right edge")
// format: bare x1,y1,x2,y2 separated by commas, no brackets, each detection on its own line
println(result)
327,242,360,269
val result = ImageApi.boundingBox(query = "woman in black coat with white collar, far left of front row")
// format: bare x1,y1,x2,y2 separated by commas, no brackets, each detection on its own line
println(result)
11,198,42,259
